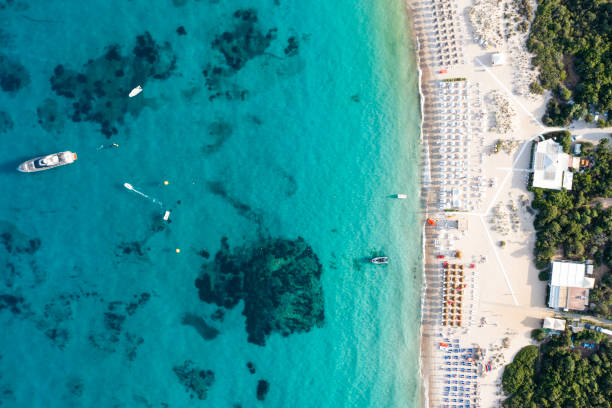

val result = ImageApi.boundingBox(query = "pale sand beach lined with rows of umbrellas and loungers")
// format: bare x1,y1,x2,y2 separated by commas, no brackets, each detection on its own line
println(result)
407,0,609,407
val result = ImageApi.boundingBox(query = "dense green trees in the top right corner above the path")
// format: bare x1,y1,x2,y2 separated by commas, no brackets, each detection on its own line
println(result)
527,0,612,126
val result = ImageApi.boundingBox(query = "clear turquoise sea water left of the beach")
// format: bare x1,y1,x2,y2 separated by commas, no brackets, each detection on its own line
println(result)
0,0,422,407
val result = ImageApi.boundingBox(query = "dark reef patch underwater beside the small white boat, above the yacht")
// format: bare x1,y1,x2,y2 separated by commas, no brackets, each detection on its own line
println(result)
51,32,176,137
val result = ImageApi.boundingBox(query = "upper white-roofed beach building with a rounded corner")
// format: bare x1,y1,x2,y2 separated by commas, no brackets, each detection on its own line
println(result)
533,139,580,190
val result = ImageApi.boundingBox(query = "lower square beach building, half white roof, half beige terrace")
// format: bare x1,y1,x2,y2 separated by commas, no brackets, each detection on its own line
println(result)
548,261,595,310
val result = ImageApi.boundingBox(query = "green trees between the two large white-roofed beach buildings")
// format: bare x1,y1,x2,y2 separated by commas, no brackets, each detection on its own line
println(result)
530,136,612,269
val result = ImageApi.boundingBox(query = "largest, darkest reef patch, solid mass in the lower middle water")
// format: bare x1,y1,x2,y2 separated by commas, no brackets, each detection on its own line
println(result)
195,237,324,346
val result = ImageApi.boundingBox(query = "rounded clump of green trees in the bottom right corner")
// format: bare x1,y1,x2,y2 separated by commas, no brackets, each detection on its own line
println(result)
502,330,612,408
